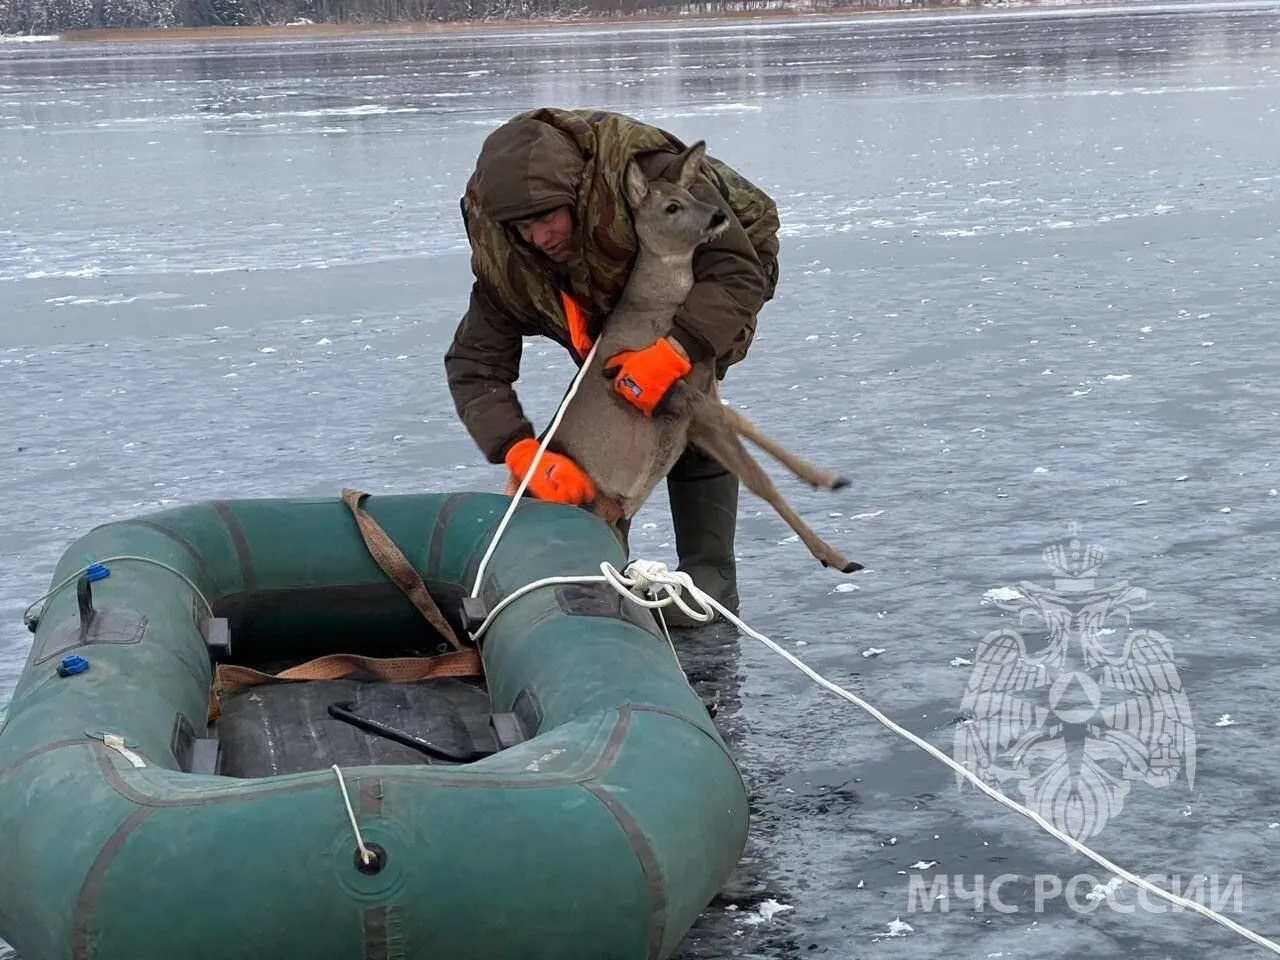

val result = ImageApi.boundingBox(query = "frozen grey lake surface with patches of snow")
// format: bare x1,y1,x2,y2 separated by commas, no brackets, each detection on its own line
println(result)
0,4,1280,960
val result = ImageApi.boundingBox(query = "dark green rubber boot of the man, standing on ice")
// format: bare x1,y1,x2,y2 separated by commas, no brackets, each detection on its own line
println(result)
662,472,739,627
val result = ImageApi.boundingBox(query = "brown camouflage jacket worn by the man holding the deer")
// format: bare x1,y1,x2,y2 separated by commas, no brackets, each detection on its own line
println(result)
444,108,778,463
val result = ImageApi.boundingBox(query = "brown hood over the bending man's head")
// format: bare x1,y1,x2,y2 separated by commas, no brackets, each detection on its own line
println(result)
475,118,585,223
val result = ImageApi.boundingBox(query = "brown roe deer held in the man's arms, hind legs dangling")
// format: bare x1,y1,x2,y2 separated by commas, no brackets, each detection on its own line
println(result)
548,141,861,573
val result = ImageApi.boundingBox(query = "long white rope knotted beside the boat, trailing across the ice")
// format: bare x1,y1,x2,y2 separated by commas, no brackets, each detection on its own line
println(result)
471,347,1280,956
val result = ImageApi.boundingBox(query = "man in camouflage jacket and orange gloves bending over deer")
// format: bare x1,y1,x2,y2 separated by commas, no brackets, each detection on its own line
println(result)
444,108,778,626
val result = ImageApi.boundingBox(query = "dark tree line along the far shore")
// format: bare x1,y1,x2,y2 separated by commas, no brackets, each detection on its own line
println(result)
0,0,965,35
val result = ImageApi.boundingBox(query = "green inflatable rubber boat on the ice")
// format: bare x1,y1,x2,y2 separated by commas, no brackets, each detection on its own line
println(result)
0,492,748,960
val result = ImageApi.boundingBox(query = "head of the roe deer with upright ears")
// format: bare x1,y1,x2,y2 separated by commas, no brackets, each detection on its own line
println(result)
623,141,728,257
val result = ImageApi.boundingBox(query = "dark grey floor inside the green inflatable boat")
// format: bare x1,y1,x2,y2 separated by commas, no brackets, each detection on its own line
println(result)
216,677,498,777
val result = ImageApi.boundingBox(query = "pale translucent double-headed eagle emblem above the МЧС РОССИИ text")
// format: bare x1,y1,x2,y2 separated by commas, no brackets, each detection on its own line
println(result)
955,539,1196,841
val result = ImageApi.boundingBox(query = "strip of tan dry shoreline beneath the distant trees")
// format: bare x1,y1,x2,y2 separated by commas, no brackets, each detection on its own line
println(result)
27,0,1125,44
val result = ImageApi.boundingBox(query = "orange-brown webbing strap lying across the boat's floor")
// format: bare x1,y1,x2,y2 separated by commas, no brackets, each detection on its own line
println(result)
209,650,484,723
